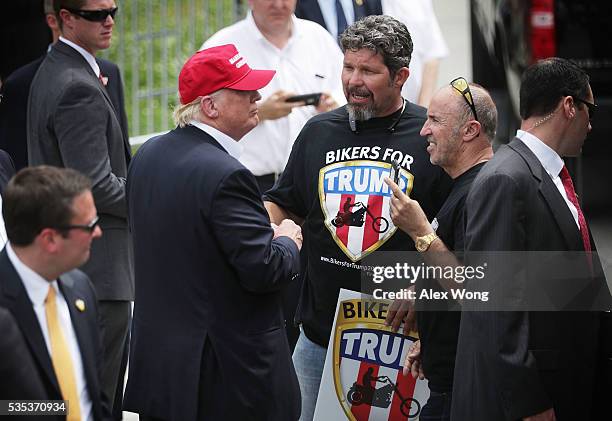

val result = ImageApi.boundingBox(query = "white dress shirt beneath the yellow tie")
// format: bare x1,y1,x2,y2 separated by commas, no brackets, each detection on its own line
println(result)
6,242,93,421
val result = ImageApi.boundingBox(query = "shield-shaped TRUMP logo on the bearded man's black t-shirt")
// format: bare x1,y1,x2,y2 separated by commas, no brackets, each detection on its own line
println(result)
319,160,414,262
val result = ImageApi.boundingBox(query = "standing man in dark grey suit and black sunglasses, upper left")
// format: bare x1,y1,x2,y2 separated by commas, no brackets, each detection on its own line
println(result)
28,0,134,408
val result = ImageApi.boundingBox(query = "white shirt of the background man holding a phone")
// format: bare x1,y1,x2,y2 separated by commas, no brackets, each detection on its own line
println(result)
202,12,346,175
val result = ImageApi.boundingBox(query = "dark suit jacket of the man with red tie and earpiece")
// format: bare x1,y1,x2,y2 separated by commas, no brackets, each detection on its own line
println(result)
451,139,609,421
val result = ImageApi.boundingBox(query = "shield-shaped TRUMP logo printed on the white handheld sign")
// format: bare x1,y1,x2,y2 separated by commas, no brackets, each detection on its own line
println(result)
333,299,429,421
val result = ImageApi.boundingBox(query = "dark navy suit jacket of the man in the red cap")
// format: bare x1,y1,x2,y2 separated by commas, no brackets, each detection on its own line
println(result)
124,126,301,421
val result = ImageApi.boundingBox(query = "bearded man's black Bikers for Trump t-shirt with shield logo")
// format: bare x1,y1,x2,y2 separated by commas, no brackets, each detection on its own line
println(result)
264,103,451,346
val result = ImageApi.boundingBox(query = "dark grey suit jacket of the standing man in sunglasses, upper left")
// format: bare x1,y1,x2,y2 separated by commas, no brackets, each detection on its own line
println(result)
27,41,134,300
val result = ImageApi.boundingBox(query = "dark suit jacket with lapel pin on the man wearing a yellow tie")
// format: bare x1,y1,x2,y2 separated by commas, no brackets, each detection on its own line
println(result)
0,248,110,421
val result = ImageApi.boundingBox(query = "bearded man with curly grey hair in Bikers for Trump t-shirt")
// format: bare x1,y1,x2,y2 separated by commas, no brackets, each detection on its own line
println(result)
264,16,450,420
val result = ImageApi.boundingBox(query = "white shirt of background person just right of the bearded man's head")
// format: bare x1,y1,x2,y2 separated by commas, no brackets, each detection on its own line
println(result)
382,0,450,102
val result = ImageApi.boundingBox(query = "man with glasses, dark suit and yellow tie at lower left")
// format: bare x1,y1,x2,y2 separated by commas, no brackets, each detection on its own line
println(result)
0,166,110,420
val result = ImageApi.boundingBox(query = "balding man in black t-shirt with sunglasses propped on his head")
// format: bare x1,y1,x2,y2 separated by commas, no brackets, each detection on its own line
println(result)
386,78,497,421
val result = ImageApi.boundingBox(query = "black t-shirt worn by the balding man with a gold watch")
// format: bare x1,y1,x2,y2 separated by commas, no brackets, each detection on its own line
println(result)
417,163,484,393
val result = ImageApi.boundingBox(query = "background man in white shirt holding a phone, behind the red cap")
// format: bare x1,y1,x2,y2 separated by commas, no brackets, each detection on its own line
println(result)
202,0,346,193
